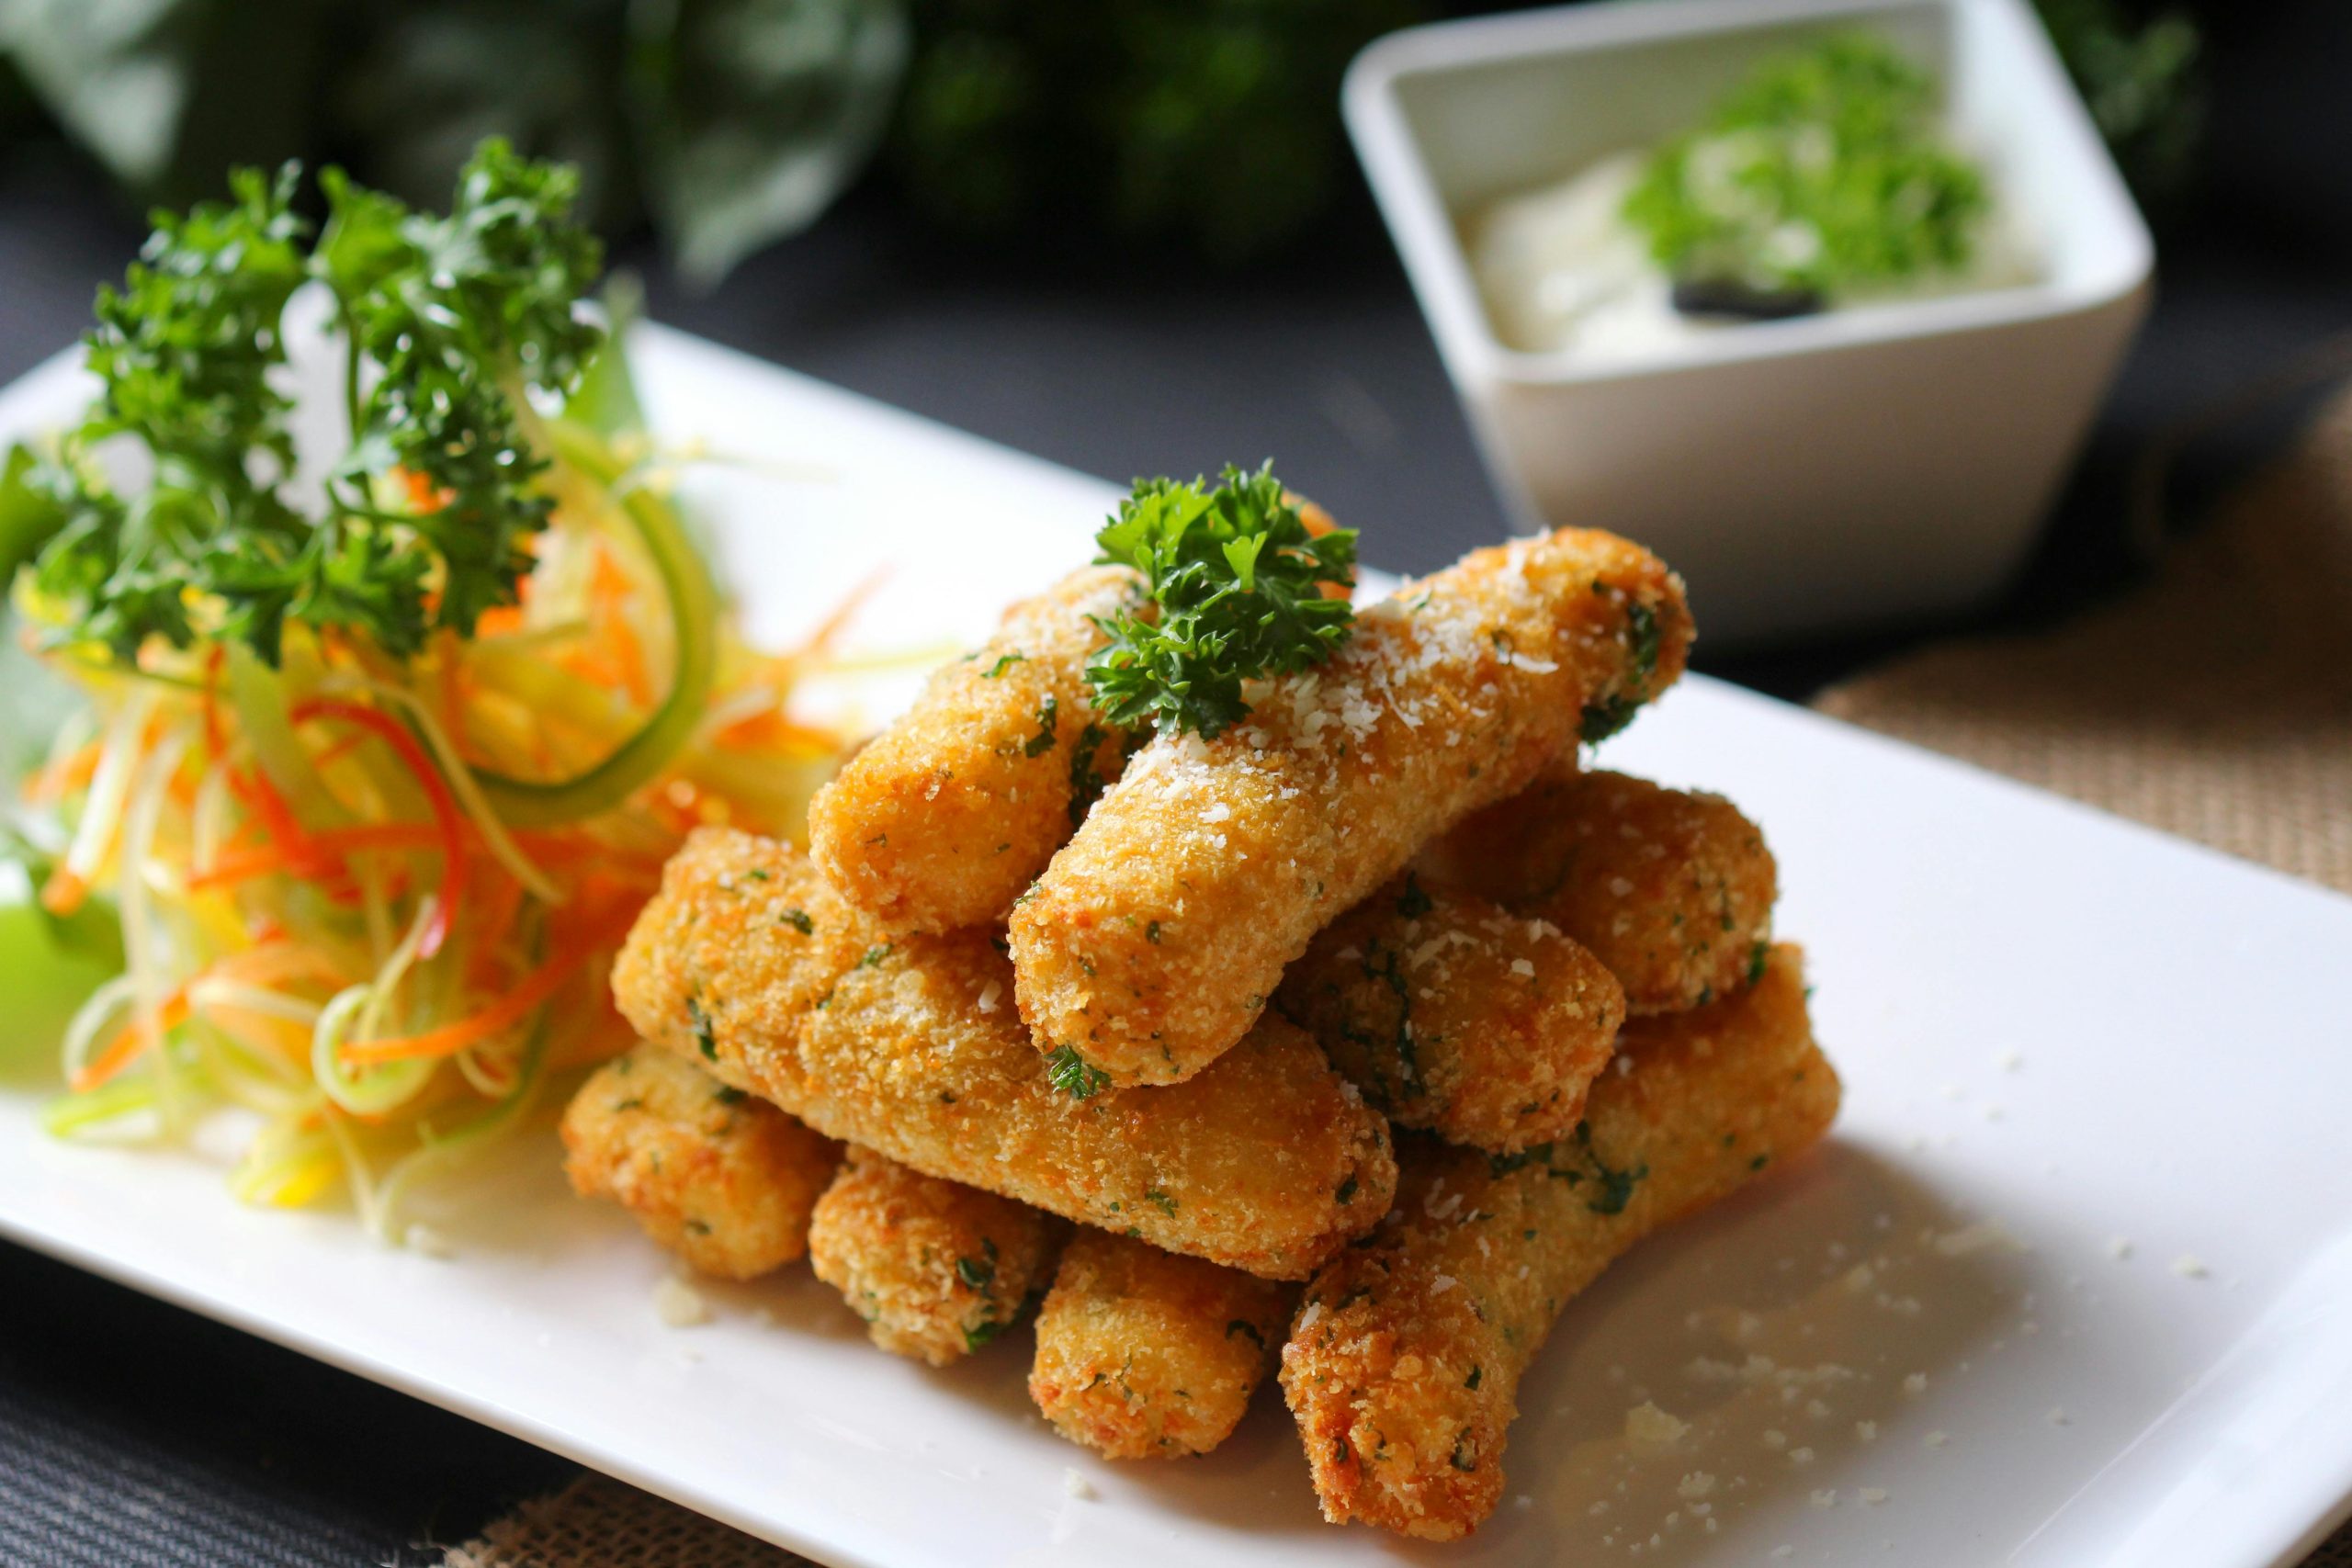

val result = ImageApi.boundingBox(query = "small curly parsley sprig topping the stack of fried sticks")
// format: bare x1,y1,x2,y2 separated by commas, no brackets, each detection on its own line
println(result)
1087,463,1355,739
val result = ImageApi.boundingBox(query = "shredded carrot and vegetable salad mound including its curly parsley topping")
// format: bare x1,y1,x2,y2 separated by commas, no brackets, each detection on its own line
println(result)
0,143,865,1241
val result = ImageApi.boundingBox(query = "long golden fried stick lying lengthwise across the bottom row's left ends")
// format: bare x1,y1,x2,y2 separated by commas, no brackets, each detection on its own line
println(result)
614,828,1397,1279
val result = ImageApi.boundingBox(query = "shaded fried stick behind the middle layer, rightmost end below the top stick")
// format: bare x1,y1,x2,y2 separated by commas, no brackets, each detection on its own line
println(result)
1420,766,1778,1013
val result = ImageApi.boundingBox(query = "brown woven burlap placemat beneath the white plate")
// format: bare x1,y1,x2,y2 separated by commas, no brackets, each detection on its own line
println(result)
447,398,2352,1568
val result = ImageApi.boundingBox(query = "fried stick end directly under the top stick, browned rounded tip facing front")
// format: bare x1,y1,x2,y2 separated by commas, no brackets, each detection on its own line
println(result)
1275,872,1625,1155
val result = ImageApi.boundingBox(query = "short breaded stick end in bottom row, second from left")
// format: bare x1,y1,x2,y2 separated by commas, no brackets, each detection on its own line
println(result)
809,1145,1061,1366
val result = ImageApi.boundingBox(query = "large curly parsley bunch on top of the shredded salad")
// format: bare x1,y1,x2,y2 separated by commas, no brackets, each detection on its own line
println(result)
14,141,600,663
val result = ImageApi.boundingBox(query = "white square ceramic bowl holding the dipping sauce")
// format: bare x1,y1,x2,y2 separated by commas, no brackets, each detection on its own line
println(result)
1345,0,2154,642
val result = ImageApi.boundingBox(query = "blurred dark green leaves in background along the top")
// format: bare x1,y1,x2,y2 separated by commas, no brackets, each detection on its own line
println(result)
0,0,2199,282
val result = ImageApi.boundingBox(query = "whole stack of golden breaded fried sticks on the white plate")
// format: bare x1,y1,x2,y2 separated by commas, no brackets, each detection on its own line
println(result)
564,517,1839,1540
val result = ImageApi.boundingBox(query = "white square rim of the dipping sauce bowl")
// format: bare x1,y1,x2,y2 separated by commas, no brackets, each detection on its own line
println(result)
1340,0,2154,386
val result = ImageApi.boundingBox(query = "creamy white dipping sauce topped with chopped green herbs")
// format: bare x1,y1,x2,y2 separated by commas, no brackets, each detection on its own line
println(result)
1463,35,2040,360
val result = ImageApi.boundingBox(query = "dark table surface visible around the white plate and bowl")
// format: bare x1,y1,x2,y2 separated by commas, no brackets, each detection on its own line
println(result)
14,0,2352,1568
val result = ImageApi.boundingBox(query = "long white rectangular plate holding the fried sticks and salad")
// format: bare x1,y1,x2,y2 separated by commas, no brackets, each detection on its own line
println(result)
0,332,2352,1568
